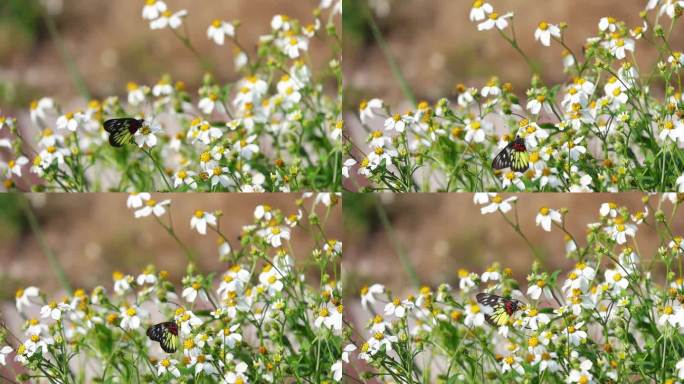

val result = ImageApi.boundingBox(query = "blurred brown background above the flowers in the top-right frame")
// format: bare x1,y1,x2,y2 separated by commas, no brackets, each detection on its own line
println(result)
344,0,684,112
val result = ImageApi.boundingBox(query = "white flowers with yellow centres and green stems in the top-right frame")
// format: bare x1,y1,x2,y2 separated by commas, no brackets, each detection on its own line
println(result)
343,0,684,192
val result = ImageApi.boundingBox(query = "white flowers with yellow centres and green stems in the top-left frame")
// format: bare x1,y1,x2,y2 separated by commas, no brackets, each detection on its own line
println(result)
0,0,343,192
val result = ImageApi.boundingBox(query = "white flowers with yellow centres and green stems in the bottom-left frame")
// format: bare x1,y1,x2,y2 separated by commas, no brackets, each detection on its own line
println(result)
0,193,343,383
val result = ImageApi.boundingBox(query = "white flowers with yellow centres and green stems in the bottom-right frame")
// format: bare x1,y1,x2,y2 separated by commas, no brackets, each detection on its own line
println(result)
343,194,684,384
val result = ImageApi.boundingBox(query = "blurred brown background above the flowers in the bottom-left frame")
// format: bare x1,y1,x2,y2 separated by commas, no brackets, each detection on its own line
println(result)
0,193,342,306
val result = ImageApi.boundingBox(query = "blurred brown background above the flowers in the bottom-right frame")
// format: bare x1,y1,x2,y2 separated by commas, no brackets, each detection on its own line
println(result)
343,193,684,300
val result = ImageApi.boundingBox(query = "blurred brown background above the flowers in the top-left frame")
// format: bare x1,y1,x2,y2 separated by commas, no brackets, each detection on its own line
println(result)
0,0,330,113
